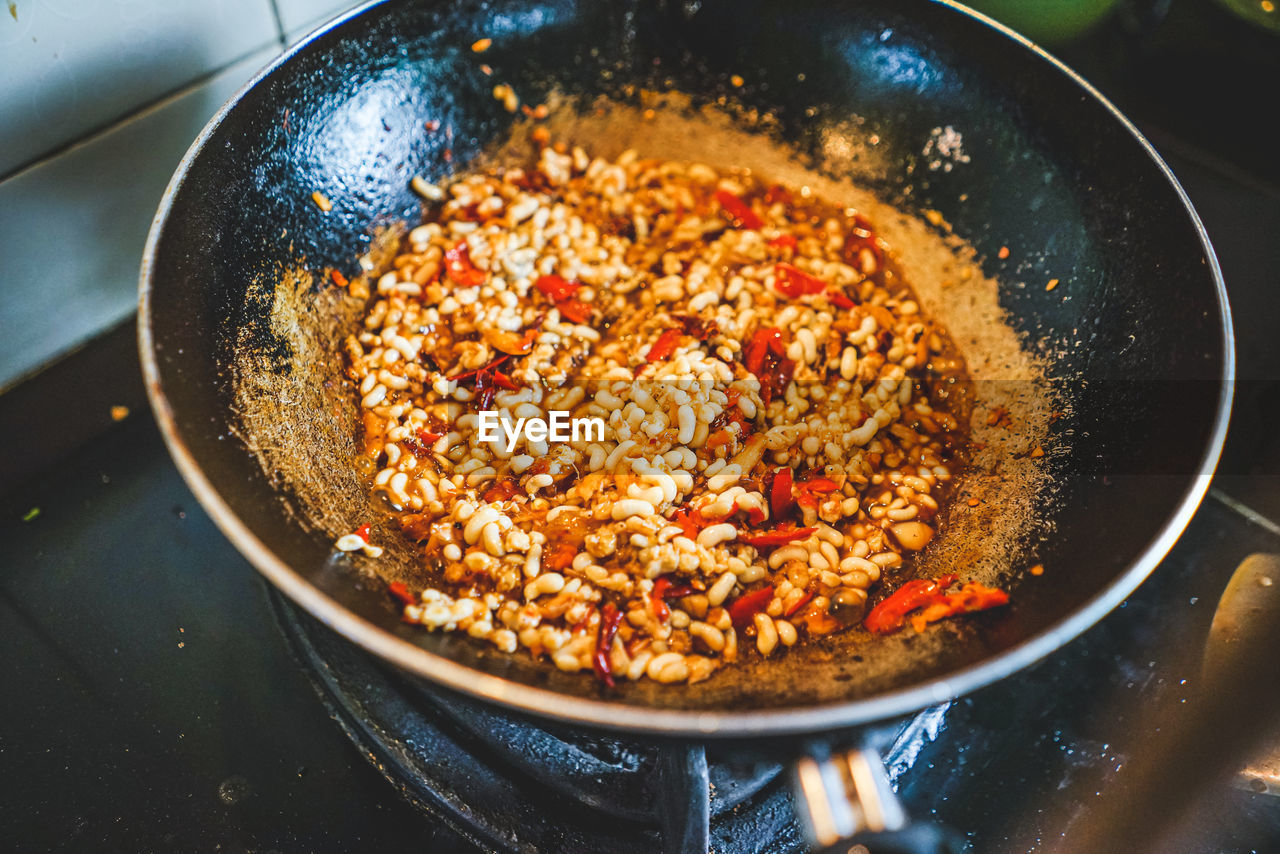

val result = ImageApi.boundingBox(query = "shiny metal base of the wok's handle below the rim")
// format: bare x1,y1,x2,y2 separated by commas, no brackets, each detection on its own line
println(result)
792,748,963,854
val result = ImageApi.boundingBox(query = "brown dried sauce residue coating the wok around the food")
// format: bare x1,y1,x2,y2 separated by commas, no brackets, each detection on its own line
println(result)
233,95,1066,708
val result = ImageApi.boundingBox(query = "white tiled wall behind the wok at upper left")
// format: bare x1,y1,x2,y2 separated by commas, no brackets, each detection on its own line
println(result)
0,0,355,389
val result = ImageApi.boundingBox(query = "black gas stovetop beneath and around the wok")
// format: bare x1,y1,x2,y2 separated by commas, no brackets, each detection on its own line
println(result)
0,3,1280,851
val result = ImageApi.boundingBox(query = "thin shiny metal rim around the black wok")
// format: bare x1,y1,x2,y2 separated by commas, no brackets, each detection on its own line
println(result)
138,0,1235,739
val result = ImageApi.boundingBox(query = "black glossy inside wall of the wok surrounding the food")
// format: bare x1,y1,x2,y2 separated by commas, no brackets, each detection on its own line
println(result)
151,0,1226,709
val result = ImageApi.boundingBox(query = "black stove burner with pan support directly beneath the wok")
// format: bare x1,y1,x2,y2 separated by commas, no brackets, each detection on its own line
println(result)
269,589,941,854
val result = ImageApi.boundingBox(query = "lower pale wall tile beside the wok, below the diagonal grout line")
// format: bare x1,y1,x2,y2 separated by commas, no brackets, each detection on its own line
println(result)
0,40,279,387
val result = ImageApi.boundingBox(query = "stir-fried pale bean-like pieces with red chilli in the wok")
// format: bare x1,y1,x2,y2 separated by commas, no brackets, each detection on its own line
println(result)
339,146,1004,685
